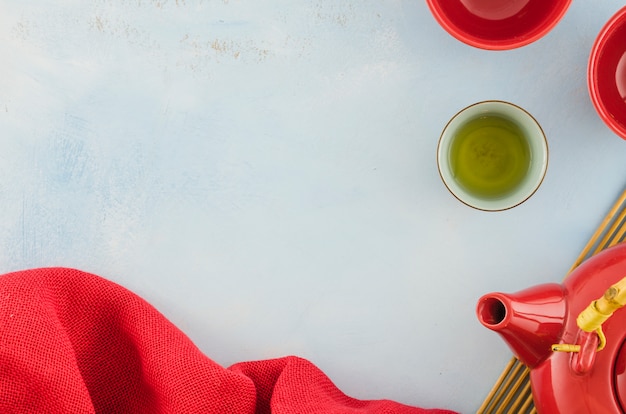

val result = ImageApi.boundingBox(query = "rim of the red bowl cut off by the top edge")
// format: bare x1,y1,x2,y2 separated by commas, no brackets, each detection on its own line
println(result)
426,0,572,50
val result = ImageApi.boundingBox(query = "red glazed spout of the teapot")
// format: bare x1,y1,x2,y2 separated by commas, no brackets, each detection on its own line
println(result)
476,283,567,368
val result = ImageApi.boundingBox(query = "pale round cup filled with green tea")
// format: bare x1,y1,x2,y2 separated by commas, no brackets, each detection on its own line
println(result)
437,101,548,211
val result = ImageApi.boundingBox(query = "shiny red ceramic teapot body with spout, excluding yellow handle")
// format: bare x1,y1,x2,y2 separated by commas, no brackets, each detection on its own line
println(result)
476,243,626,414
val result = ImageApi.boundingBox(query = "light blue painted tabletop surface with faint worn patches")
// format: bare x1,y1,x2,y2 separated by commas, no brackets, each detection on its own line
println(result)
0,0,626,413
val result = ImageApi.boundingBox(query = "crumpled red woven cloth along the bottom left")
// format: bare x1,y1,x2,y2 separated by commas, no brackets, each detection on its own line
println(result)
0,268,451,414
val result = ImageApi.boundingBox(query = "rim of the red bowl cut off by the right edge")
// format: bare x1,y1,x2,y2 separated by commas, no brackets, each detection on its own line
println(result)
587,6,626,139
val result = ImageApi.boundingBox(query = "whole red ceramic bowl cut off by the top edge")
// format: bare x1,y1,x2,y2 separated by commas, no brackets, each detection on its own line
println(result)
426,0,572,50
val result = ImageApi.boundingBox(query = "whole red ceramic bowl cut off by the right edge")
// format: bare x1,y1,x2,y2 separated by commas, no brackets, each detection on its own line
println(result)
587,7,626,139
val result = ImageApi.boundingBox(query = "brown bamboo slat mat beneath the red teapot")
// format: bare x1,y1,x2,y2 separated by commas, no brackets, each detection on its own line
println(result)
477,191,626,414
